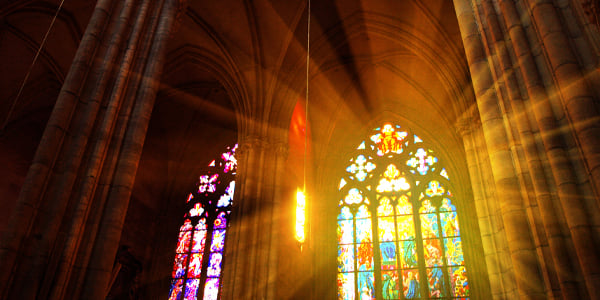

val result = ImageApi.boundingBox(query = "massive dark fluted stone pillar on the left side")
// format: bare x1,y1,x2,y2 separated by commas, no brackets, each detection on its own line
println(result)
0,0,180,299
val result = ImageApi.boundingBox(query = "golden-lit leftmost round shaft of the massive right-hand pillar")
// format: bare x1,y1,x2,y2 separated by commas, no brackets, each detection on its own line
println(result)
454,0,545,299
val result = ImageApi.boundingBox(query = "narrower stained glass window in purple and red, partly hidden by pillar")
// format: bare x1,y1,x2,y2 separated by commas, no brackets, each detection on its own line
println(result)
169,145,237,300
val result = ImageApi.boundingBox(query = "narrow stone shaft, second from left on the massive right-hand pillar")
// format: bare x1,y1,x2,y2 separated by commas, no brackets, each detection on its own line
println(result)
484,1,580,299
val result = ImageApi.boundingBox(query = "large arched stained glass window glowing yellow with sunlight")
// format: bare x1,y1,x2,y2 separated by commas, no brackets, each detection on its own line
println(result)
337,124,469,300
